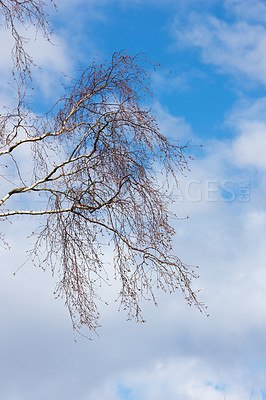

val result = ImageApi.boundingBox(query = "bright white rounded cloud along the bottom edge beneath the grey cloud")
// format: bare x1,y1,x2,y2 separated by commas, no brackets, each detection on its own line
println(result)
86,357,262,400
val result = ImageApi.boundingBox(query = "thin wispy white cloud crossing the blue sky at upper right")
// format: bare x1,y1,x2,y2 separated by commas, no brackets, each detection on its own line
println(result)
173,14,266,84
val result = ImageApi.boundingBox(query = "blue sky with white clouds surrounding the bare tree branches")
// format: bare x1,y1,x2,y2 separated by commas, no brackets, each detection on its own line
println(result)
0,0,266,400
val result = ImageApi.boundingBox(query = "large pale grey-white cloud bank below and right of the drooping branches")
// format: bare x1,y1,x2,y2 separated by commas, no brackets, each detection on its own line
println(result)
0,105,266,400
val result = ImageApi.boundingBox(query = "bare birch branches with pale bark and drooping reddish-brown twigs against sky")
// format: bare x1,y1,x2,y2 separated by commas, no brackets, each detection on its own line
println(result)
0,0,204,338
